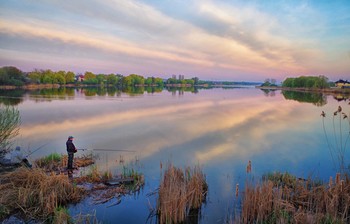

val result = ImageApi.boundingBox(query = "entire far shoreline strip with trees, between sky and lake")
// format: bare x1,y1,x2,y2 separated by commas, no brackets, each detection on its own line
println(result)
0,66,350,100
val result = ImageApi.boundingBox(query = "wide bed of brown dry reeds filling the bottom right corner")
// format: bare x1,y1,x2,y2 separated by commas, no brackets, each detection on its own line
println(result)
239,174,350,223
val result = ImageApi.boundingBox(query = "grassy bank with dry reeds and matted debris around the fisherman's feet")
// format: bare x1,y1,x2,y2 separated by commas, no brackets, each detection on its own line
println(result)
0,153,144,224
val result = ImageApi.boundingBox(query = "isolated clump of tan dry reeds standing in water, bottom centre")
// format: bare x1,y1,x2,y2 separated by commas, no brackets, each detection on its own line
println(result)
157,164,208,223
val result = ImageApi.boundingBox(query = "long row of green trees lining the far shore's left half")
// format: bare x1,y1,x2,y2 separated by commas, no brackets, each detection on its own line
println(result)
0,66,198,87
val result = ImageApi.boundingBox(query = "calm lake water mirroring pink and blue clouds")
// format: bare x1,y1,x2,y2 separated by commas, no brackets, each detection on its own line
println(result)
0,88,350,223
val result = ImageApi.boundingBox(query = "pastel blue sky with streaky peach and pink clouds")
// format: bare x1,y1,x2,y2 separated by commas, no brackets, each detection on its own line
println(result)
0,0,350,81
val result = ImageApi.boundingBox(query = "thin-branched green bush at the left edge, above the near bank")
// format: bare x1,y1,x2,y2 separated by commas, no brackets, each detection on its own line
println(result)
0,105,21,157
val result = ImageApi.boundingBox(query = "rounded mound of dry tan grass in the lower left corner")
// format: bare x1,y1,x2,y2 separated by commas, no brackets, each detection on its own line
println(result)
0,168,84,220
